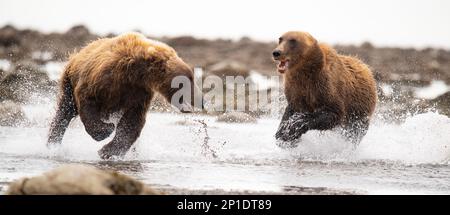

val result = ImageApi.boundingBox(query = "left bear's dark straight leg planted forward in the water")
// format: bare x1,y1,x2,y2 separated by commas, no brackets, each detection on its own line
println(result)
98,107,146,159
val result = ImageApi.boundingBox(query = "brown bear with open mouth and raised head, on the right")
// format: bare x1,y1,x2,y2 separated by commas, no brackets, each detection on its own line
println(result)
272,31,377,146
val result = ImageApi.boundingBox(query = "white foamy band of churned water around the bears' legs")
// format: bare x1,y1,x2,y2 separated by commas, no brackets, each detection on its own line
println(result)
0,101,450,164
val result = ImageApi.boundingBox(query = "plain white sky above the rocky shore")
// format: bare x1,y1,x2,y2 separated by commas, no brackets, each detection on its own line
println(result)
0,0,450,48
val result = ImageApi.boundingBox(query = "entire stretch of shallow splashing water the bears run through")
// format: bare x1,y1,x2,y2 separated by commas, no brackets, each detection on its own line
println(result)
0,99,450,194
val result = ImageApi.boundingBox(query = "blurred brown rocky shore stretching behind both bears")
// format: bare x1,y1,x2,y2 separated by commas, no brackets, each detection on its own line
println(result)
0,25,450,125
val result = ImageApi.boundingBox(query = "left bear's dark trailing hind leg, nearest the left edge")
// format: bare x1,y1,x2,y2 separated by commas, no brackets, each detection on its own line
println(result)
47,78,78,145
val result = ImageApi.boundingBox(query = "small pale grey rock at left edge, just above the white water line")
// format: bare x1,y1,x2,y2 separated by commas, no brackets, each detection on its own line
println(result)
0,101,27,126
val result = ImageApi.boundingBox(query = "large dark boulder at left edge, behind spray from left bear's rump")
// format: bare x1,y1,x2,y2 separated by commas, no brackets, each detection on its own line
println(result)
0,61,56,103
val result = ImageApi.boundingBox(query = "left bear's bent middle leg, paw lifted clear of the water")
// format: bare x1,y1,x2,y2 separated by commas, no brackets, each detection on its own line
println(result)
80,100,115,141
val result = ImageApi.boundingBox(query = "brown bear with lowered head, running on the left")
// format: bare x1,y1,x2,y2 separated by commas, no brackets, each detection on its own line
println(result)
48,33,203,159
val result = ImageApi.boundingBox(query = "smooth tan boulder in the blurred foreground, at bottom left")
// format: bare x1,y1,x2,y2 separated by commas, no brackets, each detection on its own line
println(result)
6,164,160,195
